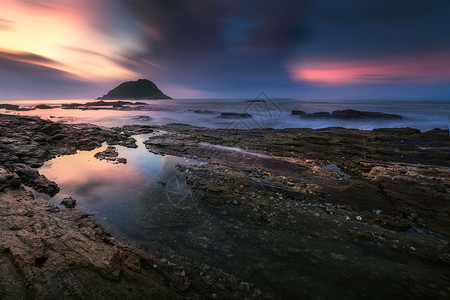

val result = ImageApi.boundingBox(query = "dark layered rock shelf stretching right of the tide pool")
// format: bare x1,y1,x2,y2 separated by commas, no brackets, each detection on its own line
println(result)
145,124,450,299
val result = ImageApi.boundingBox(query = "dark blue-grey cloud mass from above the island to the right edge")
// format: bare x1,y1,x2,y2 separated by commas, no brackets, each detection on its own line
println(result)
117,0,450,95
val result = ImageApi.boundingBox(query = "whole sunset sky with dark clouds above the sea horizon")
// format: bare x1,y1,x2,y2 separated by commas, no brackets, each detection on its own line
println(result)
0,0,450,100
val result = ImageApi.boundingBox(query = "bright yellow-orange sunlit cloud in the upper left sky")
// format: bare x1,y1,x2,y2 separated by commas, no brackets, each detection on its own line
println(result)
0,0,138,80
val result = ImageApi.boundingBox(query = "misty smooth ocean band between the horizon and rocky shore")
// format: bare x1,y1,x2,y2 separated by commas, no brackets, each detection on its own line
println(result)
0,96,450,131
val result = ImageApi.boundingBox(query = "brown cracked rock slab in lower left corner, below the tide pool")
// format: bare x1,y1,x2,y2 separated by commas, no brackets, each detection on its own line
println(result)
0,182,260,299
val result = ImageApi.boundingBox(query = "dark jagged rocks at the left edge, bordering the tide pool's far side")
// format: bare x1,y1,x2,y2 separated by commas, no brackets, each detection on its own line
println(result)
0,115,149,191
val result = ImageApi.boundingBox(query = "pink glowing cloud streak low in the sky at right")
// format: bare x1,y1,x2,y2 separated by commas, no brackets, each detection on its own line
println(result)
287,53,450,85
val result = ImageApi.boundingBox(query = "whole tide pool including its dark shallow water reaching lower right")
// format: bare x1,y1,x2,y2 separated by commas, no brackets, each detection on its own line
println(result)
29,135,450,299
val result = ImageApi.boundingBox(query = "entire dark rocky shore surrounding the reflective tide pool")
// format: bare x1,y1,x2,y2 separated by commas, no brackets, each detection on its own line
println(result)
0,115,450,299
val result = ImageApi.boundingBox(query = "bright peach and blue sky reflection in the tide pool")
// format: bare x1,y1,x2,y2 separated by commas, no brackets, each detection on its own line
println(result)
39,136,200,240
